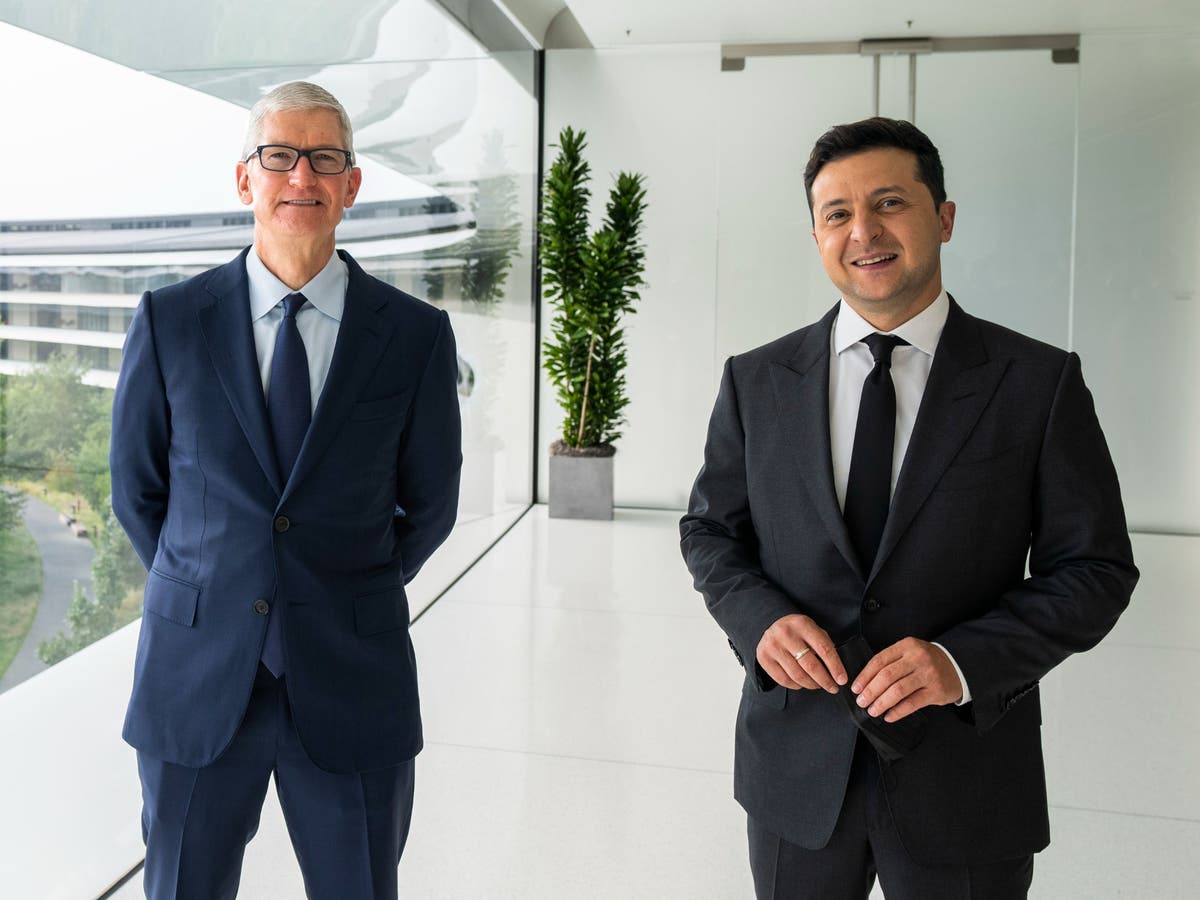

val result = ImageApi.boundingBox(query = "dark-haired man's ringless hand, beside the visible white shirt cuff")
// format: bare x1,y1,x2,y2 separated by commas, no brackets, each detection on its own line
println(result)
850,637,962,722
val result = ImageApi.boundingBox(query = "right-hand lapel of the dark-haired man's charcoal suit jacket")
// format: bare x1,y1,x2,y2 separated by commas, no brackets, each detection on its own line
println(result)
871,298,1008,577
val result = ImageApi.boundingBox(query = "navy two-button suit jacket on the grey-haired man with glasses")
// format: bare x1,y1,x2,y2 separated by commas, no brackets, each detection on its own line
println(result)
110,252,462,773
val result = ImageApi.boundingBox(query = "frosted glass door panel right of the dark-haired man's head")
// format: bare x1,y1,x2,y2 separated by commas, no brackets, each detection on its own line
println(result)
917,50,1087,348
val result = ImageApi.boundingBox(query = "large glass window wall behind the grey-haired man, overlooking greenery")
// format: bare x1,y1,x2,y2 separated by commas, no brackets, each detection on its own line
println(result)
0,7,538,691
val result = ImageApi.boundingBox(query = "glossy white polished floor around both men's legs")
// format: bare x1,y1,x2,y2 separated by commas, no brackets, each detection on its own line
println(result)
116,506,1200,900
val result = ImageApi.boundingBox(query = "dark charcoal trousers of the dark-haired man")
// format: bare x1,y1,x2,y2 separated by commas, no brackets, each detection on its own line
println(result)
748,737,1033,900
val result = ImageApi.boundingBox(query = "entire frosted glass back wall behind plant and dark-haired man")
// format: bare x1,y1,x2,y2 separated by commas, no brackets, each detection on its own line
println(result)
549,40,1200,534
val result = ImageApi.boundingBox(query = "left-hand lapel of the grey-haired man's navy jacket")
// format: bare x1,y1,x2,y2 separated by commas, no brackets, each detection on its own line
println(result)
197,248,282,493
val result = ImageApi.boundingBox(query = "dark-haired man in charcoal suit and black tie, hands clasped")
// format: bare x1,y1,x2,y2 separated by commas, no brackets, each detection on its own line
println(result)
680,119,1138,900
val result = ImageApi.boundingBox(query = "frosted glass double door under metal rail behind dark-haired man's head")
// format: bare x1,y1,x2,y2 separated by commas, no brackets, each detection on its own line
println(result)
716,50,1079,361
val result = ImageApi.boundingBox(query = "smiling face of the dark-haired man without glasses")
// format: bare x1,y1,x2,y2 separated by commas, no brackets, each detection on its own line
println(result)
812,148,954,330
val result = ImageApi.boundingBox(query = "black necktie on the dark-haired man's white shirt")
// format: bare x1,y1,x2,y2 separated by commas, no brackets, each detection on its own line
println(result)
842,334,908,572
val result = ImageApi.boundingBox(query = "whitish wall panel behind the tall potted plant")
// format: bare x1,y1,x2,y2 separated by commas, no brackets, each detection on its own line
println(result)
538,46,721,508
